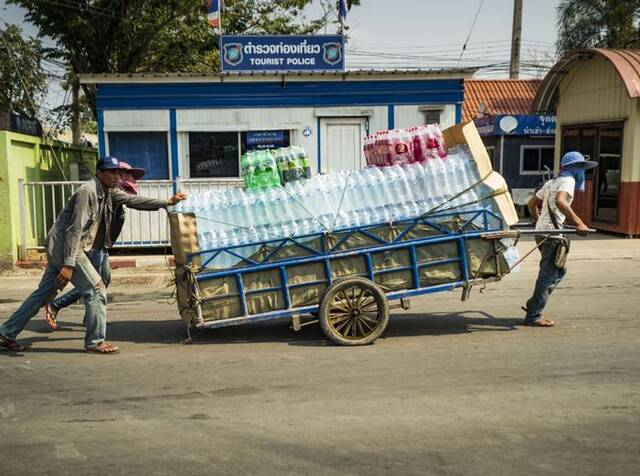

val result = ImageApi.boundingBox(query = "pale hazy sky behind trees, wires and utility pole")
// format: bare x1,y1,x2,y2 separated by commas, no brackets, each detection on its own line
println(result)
0,0,560,114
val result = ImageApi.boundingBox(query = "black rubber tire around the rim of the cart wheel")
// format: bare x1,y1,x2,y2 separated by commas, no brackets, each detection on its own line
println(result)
318,276,389,346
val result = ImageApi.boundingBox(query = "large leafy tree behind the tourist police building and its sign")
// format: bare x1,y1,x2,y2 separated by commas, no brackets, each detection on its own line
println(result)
9,0,360,114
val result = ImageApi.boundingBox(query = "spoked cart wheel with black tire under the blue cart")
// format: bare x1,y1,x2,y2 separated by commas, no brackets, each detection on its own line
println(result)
319,276,389,345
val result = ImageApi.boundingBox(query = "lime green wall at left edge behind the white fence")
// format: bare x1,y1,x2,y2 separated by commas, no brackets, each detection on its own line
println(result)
0,131,97,268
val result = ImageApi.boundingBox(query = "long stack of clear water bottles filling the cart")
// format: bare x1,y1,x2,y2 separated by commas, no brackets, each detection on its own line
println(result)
173,146,508,267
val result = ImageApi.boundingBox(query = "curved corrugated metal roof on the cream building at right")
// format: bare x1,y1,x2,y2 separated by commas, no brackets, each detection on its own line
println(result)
532,48,640,112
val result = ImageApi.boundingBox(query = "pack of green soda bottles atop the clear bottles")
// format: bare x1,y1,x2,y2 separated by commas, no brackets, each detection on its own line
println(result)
240,146,311,190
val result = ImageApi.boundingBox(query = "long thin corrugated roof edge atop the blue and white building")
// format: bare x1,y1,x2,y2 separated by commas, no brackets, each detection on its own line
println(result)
80,67,478,84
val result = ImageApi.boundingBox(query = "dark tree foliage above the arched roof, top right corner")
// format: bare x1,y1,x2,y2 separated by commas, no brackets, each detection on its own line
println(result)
556,0,640,54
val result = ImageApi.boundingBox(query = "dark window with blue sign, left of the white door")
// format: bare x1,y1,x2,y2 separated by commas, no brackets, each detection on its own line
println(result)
189,130,290,178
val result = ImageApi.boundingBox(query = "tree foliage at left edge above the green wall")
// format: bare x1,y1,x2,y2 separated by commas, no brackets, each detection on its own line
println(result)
0,25,47,118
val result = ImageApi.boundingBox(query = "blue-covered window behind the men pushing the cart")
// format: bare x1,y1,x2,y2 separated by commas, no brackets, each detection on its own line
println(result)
109,132,169,180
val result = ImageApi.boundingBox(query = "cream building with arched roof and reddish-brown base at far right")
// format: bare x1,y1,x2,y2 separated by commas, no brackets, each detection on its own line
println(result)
533,49,640,236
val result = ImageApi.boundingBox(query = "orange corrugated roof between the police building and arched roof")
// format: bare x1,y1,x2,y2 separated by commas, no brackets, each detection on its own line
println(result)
462,79,542,121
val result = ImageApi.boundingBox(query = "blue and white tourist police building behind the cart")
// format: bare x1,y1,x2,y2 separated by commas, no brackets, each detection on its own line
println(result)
81,69,474,190
